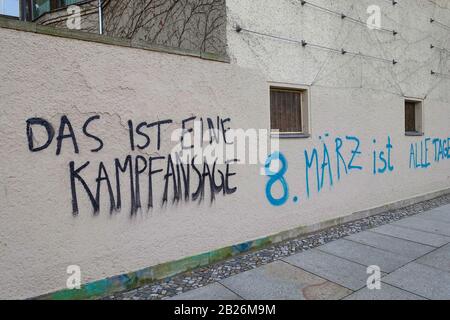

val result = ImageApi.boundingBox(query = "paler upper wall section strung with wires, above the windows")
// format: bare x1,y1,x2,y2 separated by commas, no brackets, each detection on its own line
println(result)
227,0,450,102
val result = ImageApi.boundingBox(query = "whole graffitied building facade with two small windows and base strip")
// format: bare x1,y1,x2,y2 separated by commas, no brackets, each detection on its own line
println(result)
0,0,450,298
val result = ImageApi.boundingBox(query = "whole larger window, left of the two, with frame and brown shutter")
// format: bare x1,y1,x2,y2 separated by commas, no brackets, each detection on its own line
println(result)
270,87,309,138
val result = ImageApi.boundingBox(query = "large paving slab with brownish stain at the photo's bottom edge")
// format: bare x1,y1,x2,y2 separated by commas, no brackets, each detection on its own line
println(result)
220,261,352,300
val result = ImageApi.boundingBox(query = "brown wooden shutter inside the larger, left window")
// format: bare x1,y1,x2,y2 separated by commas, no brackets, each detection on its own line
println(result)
270,88,303,133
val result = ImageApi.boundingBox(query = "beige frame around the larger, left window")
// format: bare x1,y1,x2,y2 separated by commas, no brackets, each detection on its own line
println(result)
268,82,311,139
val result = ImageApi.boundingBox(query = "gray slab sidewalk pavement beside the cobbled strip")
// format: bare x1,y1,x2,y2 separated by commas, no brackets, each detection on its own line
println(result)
170,205,450,300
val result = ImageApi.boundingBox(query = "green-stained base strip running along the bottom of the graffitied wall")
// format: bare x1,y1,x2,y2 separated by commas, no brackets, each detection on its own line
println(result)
34,188,450,300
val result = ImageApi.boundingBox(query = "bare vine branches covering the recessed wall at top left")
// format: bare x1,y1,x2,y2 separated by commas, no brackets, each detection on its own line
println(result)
38,0,226,54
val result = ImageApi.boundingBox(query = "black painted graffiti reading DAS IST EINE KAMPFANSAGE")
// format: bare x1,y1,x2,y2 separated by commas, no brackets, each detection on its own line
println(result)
26,115,237,215
